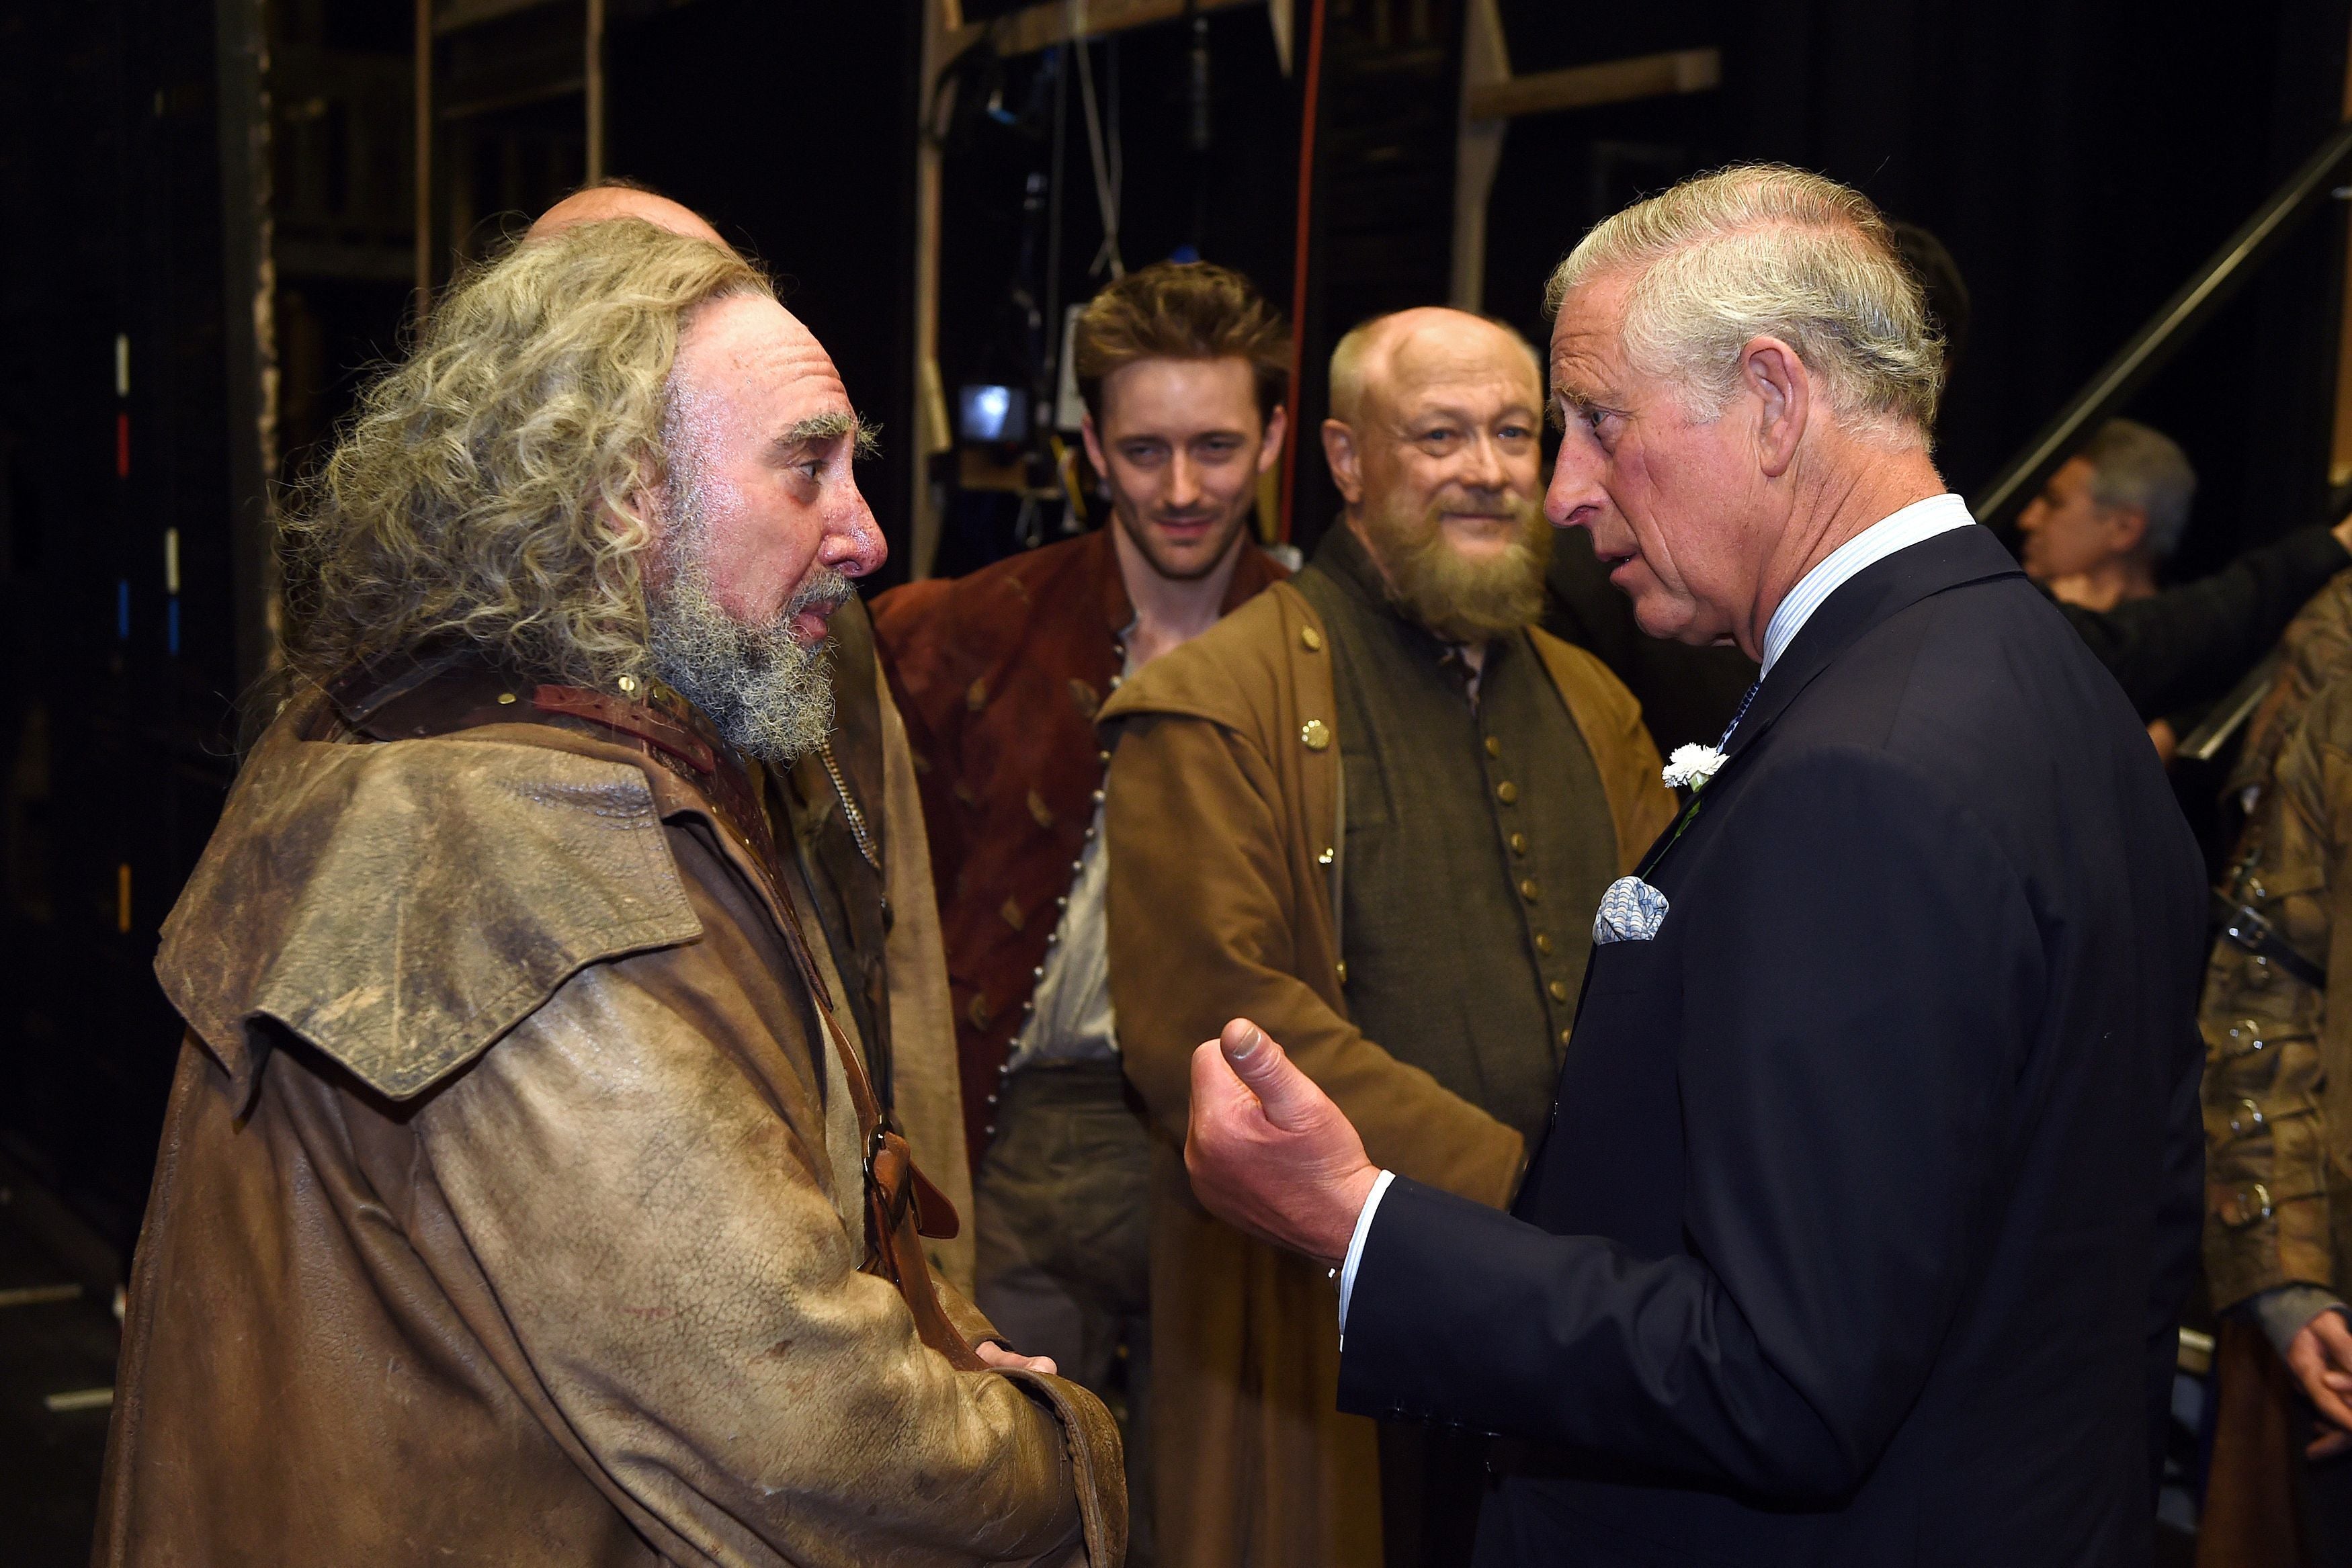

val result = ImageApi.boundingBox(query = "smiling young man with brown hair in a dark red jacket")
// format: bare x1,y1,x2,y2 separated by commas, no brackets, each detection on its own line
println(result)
875,261,1289,1561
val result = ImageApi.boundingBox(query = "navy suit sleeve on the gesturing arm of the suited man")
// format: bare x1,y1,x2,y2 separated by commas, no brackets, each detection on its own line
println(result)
1341,750,2044,1500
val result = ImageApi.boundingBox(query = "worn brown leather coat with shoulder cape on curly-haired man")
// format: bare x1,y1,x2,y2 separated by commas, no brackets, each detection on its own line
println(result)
97,681,1118,1566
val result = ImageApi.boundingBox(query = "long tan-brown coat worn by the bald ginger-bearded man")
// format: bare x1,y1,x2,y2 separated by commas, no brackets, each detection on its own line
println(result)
1103,585,1675,1568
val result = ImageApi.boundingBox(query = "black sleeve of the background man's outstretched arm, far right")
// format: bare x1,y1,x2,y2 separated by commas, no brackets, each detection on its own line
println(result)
2058,527,2352,720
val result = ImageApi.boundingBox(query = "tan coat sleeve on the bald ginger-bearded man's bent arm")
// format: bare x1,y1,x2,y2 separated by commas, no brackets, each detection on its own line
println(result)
1105,715,1524,1206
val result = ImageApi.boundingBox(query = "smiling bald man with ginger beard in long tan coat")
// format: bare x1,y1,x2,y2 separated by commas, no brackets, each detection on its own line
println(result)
1103,310,1673,1568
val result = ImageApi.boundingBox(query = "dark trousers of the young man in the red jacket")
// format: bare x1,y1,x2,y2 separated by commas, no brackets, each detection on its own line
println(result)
974,1063,1152,1568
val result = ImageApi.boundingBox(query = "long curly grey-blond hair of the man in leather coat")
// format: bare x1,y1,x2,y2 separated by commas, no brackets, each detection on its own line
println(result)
282,218,774,689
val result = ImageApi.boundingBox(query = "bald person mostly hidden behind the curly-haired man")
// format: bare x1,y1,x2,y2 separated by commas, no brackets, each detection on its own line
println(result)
525,179,974,1295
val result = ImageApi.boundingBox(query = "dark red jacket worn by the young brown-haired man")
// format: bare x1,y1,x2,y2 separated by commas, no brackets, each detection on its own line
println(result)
873,529,1287,1171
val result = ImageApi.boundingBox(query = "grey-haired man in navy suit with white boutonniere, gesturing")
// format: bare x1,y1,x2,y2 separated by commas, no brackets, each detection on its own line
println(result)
1188,167,2204,1568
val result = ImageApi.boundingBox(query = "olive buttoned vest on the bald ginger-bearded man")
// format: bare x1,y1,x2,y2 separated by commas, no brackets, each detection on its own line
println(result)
1294,524,1618,1140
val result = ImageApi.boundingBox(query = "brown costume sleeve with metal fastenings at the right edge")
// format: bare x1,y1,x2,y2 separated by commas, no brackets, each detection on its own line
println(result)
2201,682,2352,1307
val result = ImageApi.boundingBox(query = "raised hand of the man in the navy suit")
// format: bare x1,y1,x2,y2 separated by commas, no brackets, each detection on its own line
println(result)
1183,1018,1381,1267
